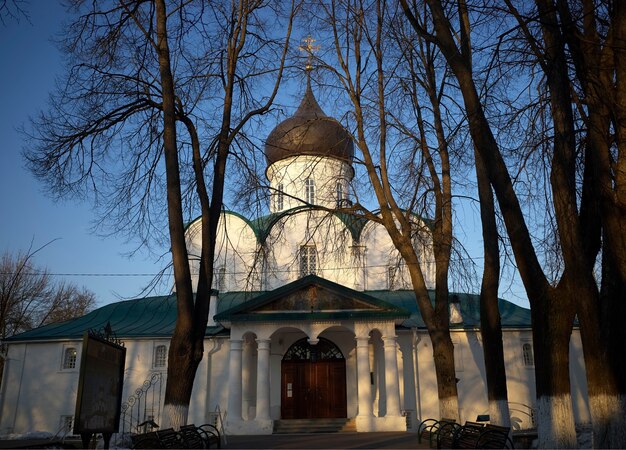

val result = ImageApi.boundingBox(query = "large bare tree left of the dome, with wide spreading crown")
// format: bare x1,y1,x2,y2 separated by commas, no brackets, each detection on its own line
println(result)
26,0,295,427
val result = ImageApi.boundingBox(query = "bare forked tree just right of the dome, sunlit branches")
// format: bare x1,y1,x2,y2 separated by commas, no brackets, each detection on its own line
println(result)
308,0,459,417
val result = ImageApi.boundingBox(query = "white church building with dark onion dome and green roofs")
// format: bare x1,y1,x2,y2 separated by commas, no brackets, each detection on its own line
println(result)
0,86,590,435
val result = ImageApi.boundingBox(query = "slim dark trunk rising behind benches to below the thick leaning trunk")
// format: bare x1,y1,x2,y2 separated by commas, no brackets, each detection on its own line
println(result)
475,152,511,427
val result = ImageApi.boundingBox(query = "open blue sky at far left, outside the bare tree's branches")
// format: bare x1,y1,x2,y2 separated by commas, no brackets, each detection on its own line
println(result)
0,0,169,305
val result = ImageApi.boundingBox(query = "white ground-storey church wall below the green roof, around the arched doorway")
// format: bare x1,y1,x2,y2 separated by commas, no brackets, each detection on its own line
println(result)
0,323,590,434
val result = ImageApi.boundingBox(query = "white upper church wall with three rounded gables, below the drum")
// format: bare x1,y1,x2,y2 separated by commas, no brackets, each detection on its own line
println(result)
187,210,434,291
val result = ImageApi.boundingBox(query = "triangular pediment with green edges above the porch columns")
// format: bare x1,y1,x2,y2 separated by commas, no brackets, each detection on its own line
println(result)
215,275,409,321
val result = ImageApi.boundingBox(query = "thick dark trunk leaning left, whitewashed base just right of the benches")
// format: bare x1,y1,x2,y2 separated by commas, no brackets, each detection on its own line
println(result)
401,0,576,447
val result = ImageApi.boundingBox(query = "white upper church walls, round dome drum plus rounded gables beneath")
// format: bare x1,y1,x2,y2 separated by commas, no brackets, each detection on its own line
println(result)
187,162,434,292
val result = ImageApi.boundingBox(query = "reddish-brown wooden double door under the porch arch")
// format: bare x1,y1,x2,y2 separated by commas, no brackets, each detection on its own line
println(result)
281,359,347,419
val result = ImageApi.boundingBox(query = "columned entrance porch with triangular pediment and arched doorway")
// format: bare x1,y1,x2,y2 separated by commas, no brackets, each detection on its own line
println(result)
216,277,407,434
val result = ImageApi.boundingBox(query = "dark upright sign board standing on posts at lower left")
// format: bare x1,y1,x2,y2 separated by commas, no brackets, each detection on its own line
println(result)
74,332,126,435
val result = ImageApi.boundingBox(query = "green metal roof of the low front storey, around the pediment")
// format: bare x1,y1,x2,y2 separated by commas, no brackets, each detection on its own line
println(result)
6,277,531,342
